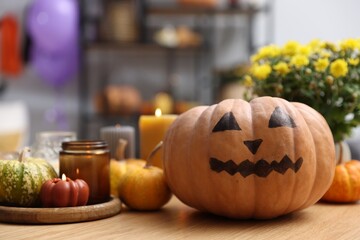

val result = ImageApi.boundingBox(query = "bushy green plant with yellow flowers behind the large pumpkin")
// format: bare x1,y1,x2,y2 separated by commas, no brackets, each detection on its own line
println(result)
242,39,360,161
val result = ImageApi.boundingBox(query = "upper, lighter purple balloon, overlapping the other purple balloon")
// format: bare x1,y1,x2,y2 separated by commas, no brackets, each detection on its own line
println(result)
27,0,79,52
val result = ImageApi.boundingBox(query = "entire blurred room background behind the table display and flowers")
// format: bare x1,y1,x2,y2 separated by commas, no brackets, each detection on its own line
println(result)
0,0,360,156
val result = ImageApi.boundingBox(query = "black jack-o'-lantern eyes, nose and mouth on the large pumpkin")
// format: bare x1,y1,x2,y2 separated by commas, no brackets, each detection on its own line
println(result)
209,106,303,177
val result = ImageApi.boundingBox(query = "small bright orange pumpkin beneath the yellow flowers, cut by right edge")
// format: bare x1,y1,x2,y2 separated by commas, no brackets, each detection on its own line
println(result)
322,160,360,203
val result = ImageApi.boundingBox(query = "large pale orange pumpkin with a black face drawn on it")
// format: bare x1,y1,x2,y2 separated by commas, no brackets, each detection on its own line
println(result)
164,97,335,219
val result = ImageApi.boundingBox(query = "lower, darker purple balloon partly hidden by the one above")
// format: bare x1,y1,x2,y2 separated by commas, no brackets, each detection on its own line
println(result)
31,45,79,88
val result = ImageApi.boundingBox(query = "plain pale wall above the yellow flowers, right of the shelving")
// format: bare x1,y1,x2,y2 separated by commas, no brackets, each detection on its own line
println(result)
274,0,360,44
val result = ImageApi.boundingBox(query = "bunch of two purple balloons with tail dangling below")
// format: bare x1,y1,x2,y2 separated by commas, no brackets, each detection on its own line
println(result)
26,0,79,130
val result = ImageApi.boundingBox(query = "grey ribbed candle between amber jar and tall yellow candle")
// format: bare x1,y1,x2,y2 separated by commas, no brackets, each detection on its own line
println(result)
100,124,135,160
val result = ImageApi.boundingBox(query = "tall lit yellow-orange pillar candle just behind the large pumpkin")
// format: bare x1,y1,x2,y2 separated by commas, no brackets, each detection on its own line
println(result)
139,109,177,168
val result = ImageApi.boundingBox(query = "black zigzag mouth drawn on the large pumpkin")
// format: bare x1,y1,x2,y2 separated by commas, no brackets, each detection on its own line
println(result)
209,155,303,177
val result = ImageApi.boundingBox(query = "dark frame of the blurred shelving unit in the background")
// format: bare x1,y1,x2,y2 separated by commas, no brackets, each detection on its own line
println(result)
79,0,269,138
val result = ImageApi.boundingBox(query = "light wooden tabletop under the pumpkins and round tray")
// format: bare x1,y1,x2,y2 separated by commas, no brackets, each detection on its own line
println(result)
0,197,360,240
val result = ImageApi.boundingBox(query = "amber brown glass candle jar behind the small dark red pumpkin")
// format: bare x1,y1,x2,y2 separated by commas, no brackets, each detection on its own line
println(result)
60,140,110,204
